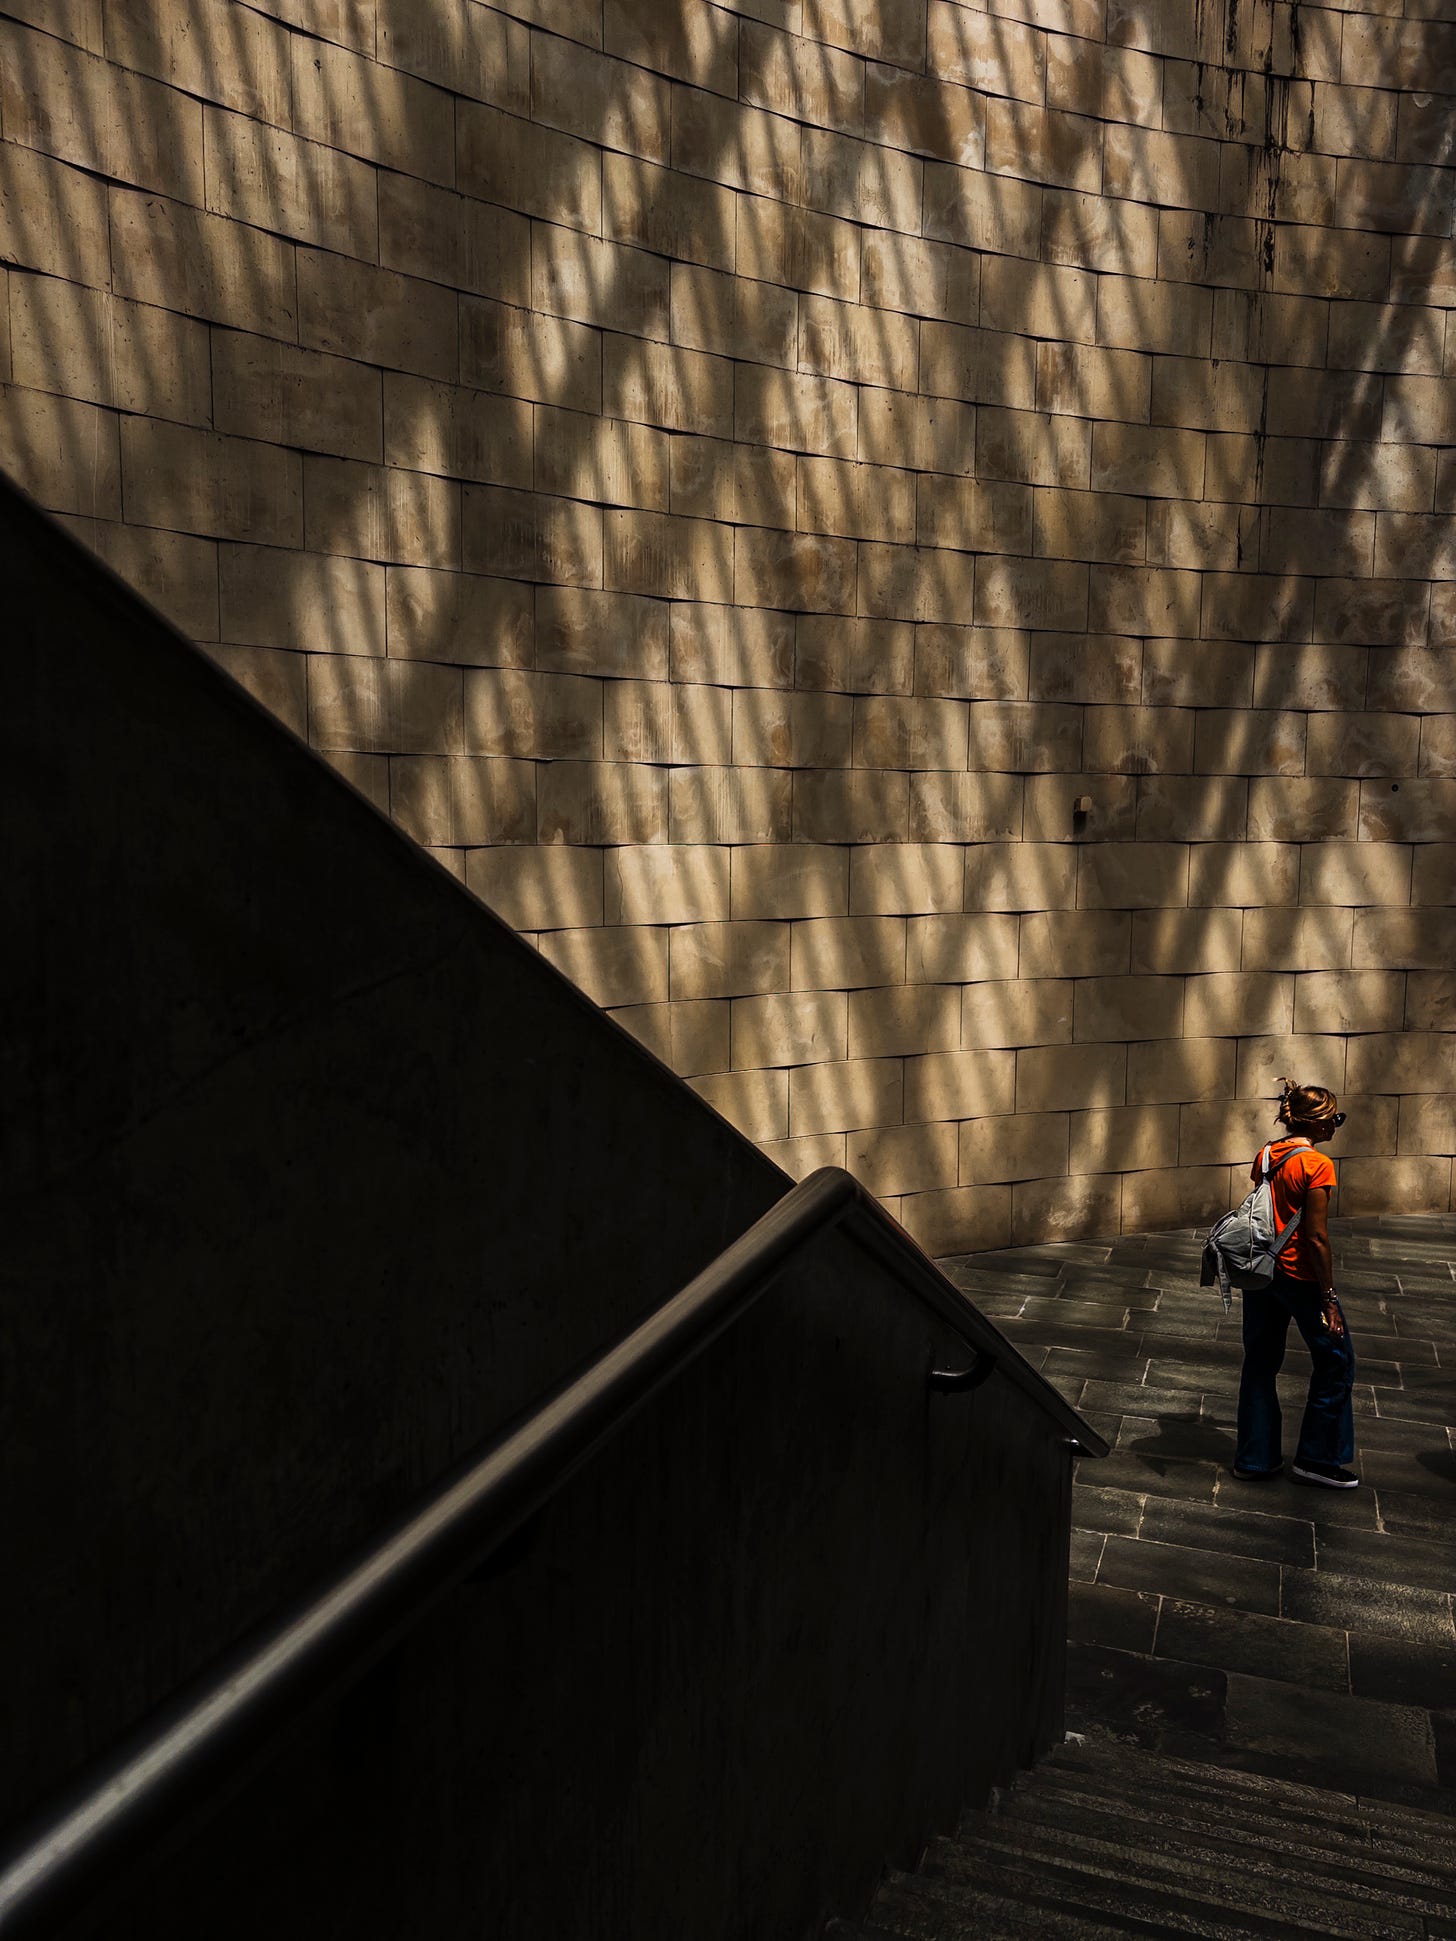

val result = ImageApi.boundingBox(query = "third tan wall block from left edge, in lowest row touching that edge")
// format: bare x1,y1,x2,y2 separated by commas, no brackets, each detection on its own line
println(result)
308,454,462,571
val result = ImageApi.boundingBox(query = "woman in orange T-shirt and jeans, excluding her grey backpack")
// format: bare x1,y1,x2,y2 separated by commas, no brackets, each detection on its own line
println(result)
1233,1079,1359,1489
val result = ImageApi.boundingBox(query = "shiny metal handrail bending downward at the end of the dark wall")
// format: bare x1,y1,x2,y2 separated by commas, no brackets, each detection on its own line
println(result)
0,1167,1107,1941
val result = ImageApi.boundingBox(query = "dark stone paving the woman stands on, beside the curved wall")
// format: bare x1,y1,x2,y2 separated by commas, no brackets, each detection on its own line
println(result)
942,1215,1456,1813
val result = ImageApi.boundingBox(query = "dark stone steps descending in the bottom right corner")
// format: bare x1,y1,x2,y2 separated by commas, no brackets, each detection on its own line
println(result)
829,1739,1456,1941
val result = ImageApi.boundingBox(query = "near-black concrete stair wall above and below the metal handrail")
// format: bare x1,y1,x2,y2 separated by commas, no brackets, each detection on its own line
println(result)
0,473,1068,1941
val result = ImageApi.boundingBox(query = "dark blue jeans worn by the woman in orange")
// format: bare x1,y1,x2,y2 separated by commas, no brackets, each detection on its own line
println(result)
1233,1271,1355,1469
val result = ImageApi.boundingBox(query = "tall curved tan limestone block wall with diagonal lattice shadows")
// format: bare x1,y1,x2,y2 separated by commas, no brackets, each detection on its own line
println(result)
0,0,1456,1252
